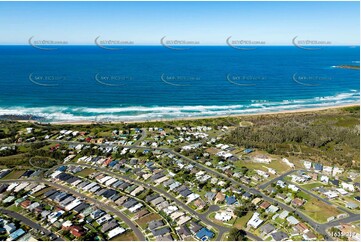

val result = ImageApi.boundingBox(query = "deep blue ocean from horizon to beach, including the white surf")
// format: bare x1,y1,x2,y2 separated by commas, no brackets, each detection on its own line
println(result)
0,46,360,121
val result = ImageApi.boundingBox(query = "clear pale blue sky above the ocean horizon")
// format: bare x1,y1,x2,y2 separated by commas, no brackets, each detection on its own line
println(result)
0,2,360,45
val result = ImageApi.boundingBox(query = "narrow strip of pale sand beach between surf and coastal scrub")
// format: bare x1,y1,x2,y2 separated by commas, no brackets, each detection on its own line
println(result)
13,103,360,125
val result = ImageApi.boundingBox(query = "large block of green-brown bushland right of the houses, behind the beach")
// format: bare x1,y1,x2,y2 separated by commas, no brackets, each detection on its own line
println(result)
227,106,360,168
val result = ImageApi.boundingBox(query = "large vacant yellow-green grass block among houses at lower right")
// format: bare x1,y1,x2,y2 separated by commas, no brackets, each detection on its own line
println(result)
301,197,341,223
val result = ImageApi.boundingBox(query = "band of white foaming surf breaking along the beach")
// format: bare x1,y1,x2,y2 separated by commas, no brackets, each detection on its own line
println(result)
0,90,360,122
